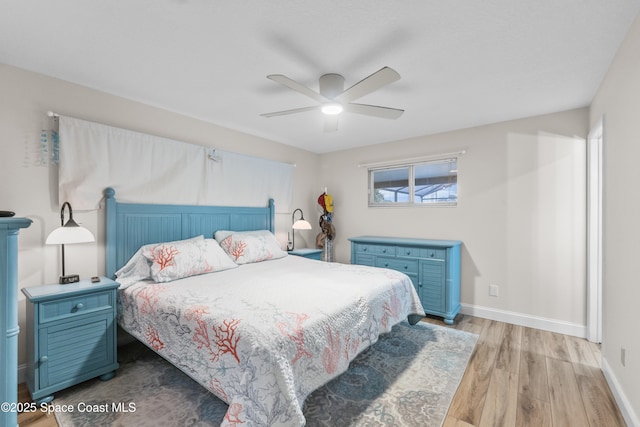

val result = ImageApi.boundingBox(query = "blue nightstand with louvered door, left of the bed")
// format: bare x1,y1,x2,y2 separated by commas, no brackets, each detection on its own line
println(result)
22,277,119,403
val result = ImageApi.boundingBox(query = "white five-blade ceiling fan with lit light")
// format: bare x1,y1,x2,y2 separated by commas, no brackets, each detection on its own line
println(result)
261,67,404,132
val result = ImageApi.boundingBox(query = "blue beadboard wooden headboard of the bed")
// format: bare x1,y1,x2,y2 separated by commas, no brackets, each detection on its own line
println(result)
103,188,275,278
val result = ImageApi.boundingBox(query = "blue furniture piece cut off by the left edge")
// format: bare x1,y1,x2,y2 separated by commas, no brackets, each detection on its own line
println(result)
0,217,32,426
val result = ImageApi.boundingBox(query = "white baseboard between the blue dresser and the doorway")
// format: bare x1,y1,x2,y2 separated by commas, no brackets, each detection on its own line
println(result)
460,304,587,338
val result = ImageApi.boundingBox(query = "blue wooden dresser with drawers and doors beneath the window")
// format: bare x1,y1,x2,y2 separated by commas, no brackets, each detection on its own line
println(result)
349,236,462,325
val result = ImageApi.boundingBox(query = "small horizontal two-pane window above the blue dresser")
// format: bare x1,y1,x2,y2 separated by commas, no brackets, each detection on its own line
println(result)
369,158,458,206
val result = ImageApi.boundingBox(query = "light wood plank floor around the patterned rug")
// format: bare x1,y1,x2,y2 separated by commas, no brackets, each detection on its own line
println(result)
18,316,625,427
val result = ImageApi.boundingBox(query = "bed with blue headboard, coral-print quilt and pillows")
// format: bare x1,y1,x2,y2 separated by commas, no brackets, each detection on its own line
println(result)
104,188,424,426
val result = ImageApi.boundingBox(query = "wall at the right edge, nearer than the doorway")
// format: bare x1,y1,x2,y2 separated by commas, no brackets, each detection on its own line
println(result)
590,11,640,426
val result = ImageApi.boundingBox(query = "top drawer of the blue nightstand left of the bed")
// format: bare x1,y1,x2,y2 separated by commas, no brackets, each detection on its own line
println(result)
38,291,114,323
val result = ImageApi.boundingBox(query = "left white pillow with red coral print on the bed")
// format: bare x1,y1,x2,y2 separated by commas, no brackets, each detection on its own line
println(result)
142,236,233,283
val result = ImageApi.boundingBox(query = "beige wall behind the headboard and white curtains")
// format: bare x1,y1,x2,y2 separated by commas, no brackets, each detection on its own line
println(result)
0,64,319,364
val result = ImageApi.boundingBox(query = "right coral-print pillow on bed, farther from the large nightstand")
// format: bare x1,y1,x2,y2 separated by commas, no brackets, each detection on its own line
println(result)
215,230,287,264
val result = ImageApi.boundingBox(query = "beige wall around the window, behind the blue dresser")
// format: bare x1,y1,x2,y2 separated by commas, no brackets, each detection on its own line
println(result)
321,108,588,335
